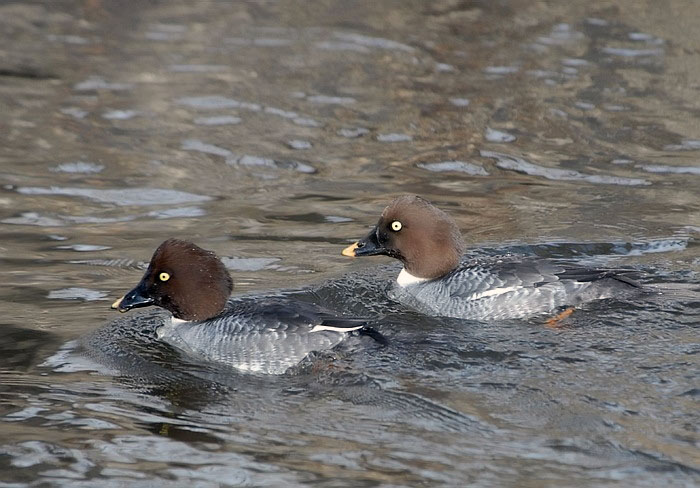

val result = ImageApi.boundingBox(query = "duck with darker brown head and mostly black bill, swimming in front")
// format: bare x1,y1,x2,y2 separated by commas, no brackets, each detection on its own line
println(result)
111,239,383,374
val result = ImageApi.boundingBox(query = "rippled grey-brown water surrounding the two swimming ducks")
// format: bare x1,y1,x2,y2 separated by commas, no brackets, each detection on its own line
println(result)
0,0,700,487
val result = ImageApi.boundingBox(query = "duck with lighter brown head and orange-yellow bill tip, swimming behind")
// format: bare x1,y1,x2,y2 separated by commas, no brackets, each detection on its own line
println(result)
342,195,641,325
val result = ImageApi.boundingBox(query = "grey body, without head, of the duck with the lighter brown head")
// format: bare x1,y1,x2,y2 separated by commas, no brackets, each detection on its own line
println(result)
389,257,639,320
